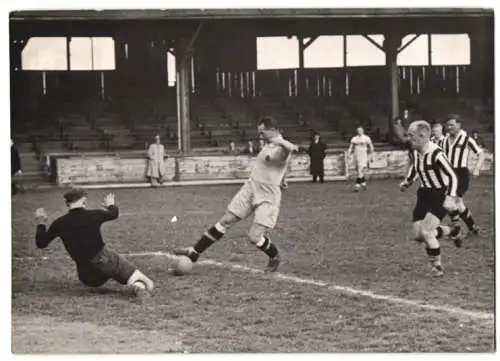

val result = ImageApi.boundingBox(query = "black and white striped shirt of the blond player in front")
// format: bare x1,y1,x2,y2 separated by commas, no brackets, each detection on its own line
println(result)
406,143,458,197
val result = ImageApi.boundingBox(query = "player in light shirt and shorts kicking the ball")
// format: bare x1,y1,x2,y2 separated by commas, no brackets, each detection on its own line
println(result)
174,117,298,272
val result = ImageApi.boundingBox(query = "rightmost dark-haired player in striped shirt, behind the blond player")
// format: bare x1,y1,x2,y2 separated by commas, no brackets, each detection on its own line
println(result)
443,115,484,238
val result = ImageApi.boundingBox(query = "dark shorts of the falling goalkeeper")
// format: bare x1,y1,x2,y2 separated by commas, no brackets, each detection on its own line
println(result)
77,247,137,287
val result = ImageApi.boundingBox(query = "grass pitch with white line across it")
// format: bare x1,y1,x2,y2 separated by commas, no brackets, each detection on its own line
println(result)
12,177,495,353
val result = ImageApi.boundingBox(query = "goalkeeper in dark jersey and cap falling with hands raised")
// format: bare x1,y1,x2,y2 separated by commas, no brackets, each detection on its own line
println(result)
36,189,154,296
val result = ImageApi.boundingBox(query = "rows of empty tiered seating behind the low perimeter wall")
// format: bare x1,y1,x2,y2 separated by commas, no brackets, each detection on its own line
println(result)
14,96,493,162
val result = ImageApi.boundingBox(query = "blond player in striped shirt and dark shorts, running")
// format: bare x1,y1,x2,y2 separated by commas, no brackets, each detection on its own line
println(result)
400,120,460,277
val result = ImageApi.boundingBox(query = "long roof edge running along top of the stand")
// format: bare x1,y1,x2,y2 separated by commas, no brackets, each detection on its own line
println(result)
10,8,493,21
